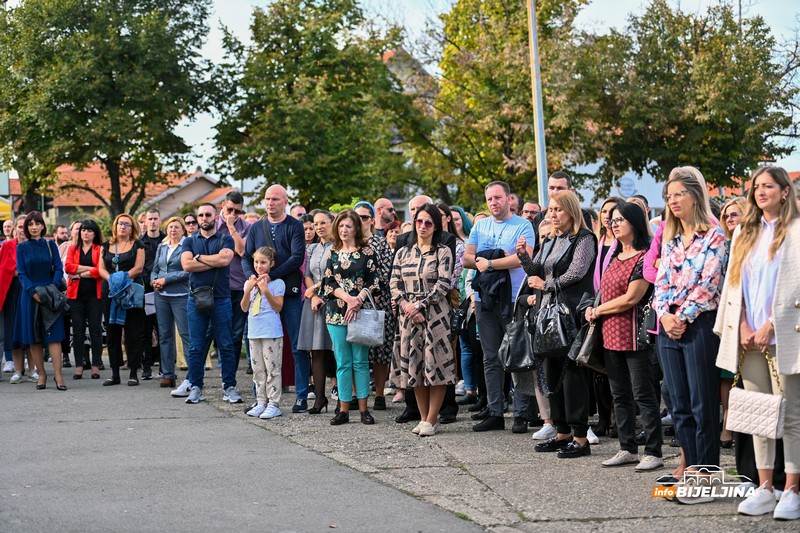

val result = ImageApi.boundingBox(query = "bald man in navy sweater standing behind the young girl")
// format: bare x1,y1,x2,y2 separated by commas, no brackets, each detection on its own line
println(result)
242,184,311,413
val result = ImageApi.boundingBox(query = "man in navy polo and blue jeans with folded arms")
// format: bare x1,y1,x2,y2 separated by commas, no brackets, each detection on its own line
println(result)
172,204,236,403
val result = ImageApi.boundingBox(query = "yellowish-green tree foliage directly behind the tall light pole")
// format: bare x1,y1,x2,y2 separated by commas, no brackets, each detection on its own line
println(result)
417,0,587,206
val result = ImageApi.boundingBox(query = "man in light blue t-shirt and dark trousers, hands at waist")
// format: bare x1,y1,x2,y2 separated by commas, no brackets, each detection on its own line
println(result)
463,181,536,433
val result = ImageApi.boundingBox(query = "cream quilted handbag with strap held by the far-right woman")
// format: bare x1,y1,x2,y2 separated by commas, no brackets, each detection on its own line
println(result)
725,350,786,439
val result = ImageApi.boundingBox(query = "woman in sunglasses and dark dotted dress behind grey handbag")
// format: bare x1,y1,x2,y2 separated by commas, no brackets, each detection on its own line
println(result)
354,202,397,411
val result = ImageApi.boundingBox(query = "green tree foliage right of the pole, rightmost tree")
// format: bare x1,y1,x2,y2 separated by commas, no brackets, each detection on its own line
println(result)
570,0,797,194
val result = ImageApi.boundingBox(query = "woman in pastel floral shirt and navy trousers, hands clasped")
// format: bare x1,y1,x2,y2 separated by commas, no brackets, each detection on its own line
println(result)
655,167,727,486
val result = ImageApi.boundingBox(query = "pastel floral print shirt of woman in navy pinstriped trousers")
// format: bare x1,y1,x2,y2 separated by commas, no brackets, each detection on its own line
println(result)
655,226,728,323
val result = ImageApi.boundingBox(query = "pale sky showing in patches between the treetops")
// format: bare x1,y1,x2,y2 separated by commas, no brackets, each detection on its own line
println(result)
178,0,800,180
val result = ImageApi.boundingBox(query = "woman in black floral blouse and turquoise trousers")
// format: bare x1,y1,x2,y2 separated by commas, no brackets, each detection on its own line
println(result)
321,209,380,426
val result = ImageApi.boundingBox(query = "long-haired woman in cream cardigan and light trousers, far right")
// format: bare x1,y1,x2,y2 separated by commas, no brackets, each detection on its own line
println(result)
714,167,800,520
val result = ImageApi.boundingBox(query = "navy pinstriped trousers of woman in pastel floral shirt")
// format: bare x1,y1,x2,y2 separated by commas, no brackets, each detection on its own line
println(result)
658,311,719,466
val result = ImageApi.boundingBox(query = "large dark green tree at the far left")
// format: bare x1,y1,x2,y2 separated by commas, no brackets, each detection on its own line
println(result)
0,0,210,216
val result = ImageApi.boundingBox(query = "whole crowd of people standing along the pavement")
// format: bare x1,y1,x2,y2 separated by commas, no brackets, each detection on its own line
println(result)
0,167,800,519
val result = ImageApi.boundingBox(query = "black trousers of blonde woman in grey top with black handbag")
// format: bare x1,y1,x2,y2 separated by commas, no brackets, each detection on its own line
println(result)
544,357,589,438
